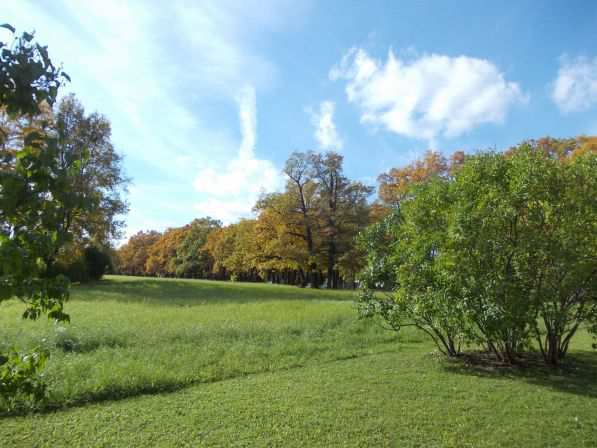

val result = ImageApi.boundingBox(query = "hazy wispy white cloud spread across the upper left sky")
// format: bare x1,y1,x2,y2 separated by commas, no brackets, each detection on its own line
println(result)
2,0,304,234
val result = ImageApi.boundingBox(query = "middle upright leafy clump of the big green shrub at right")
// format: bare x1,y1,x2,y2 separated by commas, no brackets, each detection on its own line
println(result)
447,153,536,361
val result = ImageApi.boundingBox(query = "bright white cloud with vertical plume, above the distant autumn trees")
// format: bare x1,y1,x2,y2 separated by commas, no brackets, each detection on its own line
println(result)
194,87,282,223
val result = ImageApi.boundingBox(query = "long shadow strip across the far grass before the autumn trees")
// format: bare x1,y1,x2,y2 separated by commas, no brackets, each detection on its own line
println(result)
72,277,357,306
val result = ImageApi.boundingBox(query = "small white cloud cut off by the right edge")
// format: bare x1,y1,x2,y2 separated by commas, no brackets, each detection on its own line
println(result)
551,56,597,113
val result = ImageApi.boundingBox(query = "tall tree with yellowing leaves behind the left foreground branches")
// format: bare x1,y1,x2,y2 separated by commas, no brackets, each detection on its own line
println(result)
0,91,128,281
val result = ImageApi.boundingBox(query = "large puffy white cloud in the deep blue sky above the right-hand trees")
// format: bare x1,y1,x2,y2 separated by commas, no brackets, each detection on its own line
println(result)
329,48,527,141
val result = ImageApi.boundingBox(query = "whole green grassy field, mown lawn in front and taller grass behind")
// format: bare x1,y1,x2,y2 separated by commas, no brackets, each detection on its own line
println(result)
0,277,597,447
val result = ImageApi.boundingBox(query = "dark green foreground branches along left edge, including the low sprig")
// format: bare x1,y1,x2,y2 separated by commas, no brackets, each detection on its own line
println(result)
0,25,71,406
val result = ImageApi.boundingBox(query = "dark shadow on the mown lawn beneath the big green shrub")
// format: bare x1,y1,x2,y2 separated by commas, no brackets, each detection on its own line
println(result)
443,350,597,398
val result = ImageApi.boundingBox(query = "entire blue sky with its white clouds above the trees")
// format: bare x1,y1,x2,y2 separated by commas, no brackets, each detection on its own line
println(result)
0,0,597,240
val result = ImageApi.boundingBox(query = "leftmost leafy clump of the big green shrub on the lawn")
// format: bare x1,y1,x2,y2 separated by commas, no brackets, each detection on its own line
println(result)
359,183,468,356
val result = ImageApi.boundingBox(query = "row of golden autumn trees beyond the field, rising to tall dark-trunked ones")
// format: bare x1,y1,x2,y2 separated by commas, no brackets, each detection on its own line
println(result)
116,152,375,288
